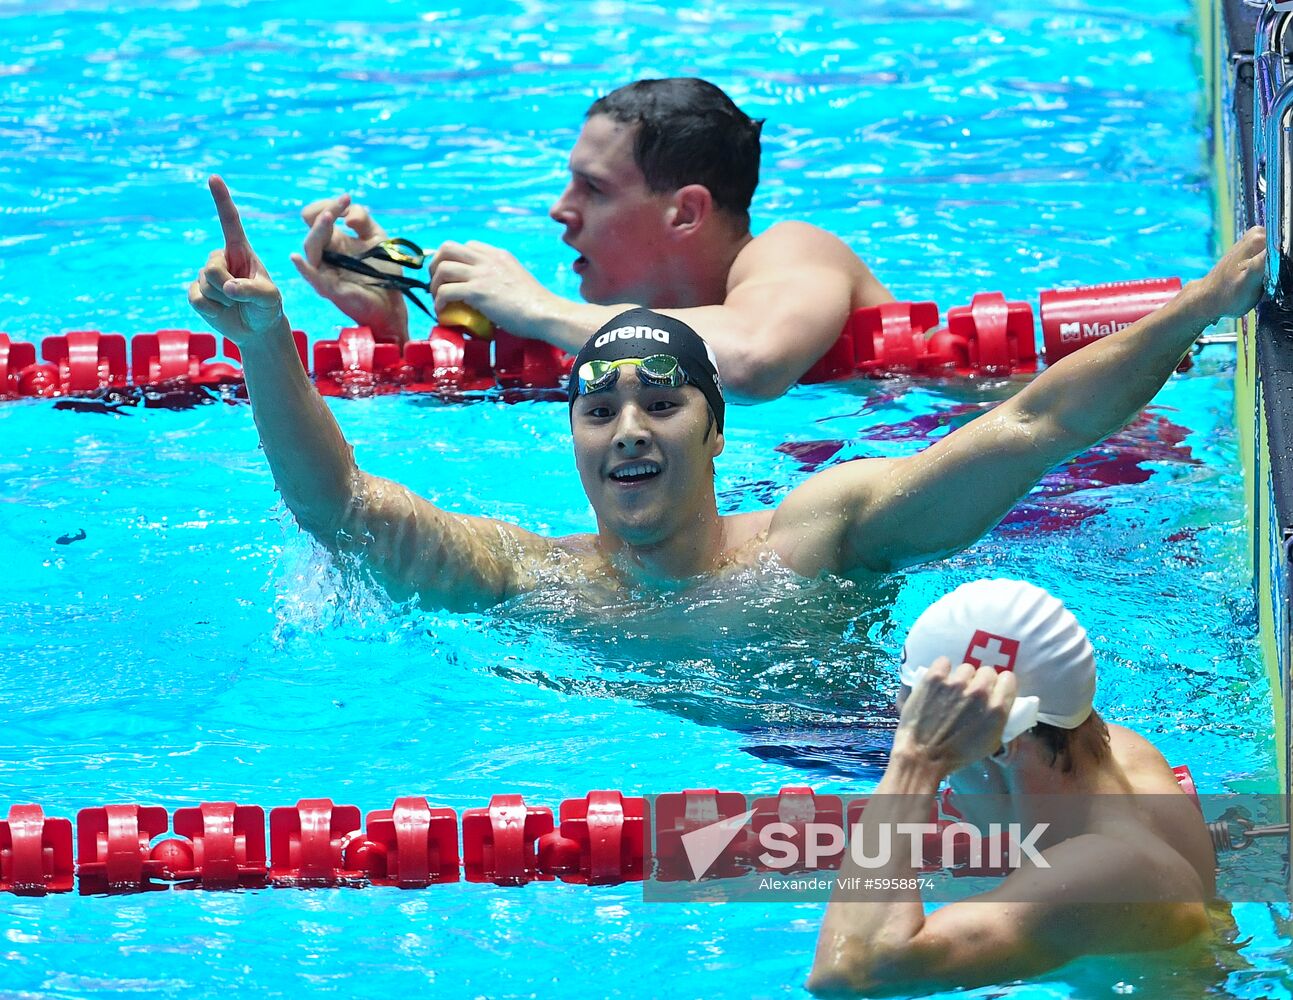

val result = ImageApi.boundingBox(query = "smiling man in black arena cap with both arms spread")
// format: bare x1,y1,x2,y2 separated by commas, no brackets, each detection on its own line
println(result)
189,177,1266,611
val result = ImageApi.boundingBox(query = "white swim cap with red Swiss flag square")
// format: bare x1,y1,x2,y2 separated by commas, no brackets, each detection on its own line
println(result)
903,580,1095,743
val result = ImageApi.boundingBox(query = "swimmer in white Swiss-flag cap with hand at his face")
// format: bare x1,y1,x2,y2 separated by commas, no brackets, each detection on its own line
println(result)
808,580,1215,995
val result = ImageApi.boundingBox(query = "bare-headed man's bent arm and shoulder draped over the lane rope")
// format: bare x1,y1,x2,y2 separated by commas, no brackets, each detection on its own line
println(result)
432,223,893,400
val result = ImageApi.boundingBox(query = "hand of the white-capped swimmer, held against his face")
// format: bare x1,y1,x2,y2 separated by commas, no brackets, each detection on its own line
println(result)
893,656,1016,776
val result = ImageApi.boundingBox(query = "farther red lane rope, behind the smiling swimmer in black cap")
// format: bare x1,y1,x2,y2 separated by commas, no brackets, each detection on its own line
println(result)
0,278,1181,397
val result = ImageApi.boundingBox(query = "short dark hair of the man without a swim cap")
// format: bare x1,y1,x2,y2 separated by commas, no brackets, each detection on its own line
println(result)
586,76,763,224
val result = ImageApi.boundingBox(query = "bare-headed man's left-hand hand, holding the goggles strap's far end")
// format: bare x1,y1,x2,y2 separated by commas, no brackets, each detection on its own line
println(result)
292,194,409,343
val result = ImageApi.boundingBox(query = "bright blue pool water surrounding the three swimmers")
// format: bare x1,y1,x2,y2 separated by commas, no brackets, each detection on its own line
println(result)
0,0,1289,997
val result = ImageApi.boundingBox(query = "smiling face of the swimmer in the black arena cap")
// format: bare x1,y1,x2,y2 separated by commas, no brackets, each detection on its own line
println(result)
570,365,723,546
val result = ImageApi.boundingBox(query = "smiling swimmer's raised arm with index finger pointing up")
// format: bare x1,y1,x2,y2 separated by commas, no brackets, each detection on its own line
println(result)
189,177,548,611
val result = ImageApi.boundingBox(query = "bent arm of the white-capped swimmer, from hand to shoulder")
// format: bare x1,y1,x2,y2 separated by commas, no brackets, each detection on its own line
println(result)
808,660,1208,995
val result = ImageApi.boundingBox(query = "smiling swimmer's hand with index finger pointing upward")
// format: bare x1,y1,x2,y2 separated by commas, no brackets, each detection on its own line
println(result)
189,177,283,345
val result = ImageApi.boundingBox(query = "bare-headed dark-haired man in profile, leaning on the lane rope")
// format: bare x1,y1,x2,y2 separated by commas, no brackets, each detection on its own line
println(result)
292,78,893,400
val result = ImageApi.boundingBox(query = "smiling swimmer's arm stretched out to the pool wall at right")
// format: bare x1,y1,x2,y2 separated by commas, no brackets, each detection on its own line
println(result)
772,229,1265,573
